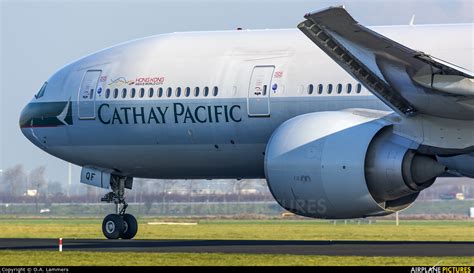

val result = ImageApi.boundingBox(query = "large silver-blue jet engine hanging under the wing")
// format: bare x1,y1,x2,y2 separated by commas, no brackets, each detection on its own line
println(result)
265,110,445,219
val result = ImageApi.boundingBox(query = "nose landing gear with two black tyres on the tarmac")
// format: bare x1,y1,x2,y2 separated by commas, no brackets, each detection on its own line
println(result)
101,177,138,239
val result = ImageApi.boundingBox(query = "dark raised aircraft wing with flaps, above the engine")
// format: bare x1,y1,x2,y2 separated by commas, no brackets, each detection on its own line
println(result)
298,7,474,120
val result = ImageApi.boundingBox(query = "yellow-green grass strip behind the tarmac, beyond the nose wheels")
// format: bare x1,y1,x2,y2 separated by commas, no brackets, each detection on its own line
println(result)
0,219,474,241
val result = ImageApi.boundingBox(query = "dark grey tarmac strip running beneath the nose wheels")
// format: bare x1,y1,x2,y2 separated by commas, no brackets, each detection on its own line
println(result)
0,238,474,257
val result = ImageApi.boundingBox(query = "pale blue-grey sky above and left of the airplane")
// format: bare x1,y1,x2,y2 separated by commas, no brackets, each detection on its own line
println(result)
0,0,474,183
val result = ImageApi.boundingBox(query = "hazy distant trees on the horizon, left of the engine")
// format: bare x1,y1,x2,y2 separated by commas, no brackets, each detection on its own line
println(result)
0,164,273,203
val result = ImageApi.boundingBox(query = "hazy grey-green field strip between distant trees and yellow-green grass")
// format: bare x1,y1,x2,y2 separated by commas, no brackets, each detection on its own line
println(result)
0,200,474,217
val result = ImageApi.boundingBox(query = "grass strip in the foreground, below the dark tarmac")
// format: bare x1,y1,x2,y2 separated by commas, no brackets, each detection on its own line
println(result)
0,251,474,266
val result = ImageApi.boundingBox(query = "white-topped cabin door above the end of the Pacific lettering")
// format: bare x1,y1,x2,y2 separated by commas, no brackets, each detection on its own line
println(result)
247,66,275,117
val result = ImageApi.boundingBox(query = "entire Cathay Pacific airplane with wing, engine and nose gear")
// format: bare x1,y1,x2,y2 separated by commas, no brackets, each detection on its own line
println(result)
19,7,474,239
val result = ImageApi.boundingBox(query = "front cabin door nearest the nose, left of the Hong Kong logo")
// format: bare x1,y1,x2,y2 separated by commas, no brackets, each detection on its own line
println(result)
77,70,102,119
